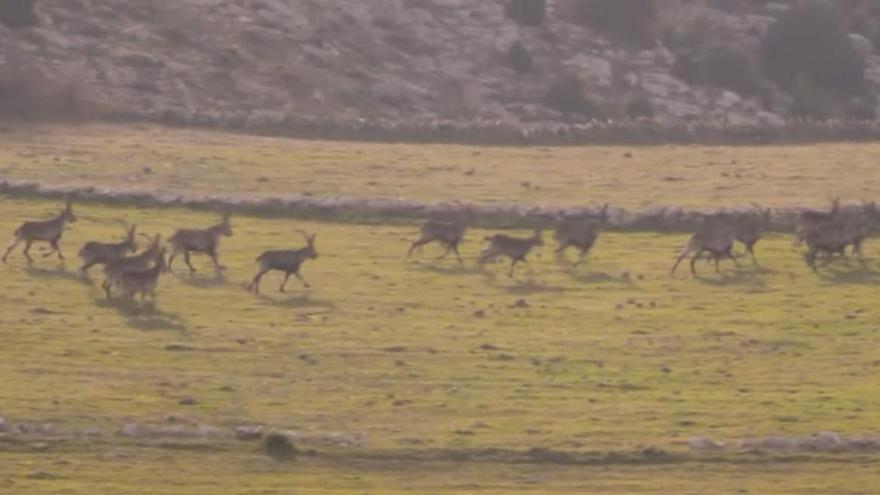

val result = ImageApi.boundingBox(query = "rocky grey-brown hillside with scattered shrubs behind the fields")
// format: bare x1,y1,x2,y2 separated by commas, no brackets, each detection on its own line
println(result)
0,0,880,130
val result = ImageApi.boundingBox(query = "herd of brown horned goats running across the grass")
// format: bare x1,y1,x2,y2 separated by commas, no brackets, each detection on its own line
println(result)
2,199,880,300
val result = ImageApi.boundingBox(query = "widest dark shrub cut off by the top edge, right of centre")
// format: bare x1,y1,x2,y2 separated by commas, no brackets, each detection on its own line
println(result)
573,0,657,48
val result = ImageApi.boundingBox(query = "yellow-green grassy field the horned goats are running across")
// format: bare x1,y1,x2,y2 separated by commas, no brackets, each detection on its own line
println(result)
0,196,880,494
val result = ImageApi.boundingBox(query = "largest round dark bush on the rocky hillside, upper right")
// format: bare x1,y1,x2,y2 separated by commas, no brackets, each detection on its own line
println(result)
761,0,865,93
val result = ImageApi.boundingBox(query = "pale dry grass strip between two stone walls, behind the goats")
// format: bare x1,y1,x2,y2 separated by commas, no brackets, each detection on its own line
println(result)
0,125,880,208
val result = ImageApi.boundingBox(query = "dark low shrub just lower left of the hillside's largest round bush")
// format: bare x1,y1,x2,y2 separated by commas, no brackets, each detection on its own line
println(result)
672,45,765,95
